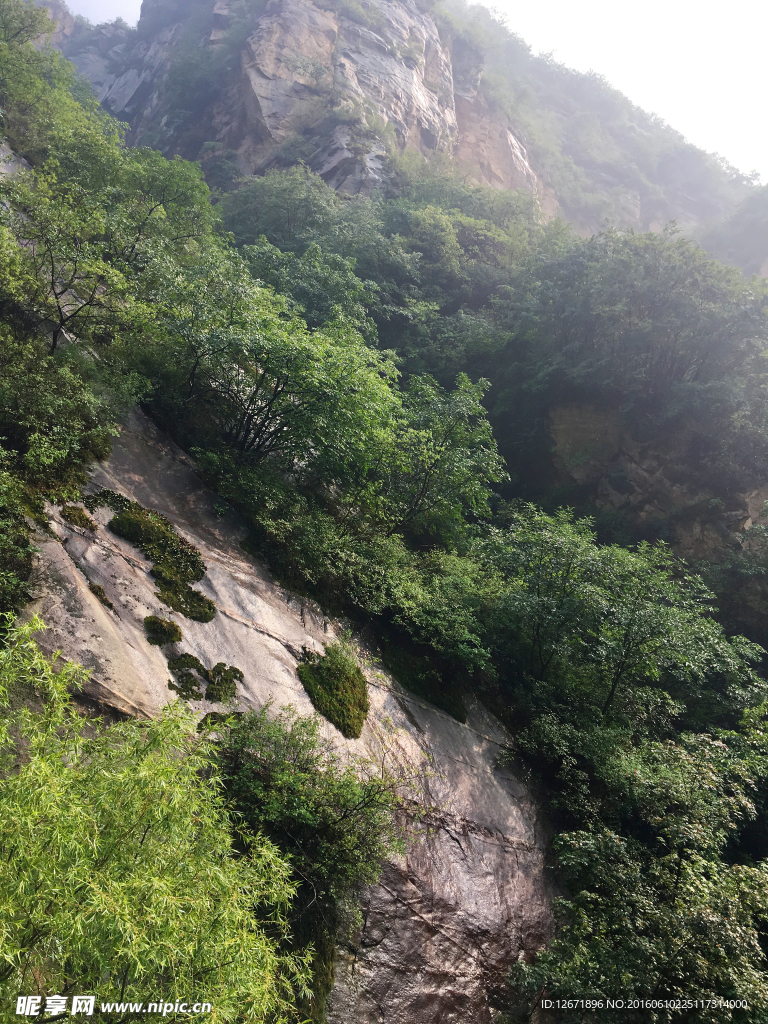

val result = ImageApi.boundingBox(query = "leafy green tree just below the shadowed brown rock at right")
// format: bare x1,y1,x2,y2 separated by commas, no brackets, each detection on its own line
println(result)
480,507,760,726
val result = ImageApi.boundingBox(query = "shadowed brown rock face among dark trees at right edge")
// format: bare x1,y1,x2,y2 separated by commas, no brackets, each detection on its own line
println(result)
550,404,768,646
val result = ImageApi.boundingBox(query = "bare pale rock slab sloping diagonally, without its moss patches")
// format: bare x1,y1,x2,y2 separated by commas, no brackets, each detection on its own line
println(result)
29,415,551,1024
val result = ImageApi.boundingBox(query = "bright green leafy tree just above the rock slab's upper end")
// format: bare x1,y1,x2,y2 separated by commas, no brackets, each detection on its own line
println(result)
141,250,397,486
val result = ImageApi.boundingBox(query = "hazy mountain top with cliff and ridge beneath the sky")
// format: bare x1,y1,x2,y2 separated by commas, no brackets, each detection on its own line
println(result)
43,0,752,231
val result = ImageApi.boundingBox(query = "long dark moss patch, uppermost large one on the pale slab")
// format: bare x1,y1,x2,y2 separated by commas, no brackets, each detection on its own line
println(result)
85,490,216,623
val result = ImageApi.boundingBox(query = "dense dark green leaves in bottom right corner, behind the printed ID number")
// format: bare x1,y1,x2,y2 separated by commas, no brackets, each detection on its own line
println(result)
513,829,768,1024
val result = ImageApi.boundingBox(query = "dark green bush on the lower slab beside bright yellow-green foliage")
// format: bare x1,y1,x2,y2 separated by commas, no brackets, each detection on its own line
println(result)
220,706,401,1021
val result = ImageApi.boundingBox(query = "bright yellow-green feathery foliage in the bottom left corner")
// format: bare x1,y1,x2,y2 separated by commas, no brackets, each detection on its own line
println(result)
0,620,306,1021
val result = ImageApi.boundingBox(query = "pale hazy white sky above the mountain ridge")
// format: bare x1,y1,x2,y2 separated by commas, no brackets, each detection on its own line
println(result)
68,0,768,182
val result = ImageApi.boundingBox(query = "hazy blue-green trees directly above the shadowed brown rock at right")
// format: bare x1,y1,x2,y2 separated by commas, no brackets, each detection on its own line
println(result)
485,229,768,494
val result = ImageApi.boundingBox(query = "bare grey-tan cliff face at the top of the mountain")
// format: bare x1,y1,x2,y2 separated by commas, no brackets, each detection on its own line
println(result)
49,0,556,199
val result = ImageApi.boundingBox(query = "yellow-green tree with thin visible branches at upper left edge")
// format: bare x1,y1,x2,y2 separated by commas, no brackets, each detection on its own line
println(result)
0,151,211,352
